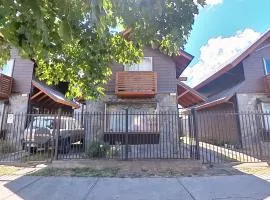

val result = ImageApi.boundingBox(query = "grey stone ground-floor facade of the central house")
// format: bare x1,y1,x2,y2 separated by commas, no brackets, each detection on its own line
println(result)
85,94,186,158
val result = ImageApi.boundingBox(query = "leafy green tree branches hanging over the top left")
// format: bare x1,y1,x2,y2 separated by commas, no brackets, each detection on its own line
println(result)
0,0,204,99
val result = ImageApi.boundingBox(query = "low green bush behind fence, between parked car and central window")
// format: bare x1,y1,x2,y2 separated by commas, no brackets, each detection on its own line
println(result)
86,141,110,158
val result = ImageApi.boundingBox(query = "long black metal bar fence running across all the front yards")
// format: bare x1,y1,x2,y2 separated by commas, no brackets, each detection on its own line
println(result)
0,110,270,163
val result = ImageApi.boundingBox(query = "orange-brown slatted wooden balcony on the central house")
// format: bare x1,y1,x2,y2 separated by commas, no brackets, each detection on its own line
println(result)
115,71,157,98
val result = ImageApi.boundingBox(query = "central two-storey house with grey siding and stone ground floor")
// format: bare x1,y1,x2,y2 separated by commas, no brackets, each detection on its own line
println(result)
85,48,193,156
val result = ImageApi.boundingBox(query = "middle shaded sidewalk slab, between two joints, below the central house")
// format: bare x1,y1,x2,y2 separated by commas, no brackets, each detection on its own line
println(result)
87,178,192,200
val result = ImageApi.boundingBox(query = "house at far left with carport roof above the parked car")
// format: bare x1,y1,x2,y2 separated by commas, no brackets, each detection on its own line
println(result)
0,49,79,138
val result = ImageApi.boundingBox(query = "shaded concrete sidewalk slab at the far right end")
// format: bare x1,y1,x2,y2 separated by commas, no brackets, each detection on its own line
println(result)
178,175,270,200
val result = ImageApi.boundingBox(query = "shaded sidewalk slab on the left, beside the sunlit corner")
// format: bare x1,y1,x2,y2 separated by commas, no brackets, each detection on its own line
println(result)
2,177,98,200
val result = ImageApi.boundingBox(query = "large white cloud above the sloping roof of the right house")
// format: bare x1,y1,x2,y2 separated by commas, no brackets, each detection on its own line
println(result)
183,28,261,87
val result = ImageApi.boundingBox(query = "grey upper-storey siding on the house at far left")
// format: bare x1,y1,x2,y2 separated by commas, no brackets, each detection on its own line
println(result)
12,57,34,94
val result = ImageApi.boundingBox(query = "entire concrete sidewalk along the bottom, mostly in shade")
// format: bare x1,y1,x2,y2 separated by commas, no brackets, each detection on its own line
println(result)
0,175,270,200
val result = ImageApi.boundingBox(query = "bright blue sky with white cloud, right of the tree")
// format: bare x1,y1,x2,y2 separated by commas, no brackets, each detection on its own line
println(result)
185,0,270,86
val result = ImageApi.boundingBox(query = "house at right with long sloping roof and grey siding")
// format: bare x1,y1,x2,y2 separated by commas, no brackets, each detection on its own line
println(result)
178,30,270,158
